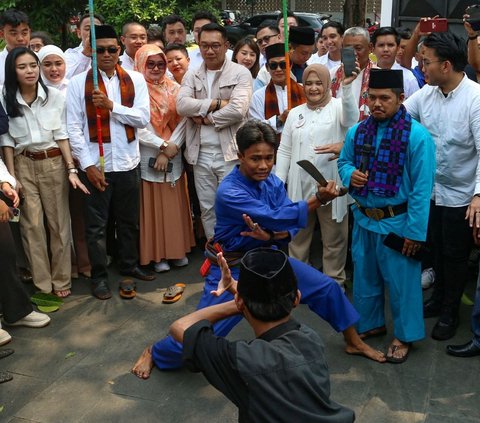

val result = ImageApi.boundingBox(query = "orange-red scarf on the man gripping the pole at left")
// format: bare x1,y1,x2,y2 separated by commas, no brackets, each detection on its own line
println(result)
85,64,135,143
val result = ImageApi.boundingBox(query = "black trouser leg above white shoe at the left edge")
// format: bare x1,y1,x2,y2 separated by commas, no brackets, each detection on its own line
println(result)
0,223,33,323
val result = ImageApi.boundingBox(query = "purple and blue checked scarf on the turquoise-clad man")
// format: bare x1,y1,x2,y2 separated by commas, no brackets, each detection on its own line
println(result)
353,105,412,197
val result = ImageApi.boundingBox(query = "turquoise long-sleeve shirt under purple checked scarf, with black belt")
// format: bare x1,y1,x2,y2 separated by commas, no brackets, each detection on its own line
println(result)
338,119,435,241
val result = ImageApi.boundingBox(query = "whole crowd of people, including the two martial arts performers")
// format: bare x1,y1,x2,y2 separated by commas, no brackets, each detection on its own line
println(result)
0,4,480,422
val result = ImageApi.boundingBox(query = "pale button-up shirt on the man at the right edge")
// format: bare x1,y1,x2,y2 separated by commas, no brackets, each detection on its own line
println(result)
405,75,480,207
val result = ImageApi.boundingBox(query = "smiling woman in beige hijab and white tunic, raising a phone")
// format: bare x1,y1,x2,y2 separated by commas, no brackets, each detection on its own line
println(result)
276,64,359,287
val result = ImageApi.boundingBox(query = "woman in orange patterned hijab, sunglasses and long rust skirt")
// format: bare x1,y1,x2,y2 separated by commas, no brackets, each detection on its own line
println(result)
135,44,195,272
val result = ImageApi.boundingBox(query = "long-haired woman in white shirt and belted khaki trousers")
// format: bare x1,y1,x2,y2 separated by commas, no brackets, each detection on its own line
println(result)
0,47,88,297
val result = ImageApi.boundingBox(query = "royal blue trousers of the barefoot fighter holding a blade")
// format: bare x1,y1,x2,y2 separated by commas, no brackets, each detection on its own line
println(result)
152,258,359,370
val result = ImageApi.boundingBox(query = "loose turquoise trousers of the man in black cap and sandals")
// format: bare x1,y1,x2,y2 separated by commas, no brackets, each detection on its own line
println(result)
352,223,425,342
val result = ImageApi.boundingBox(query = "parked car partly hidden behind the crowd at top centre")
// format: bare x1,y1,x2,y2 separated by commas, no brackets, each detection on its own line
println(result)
225,12,325,46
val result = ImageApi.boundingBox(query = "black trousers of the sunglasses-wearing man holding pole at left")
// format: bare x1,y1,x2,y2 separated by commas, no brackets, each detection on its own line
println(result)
80,167,140,280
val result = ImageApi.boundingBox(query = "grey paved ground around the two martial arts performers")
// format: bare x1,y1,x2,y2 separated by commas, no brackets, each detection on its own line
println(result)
0,245,480,423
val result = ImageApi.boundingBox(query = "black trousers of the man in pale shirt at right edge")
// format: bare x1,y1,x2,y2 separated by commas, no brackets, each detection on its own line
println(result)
429,202,473,317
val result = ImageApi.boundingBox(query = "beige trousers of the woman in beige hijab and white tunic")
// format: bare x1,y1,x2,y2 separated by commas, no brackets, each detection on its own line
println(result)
288,203,348,287
